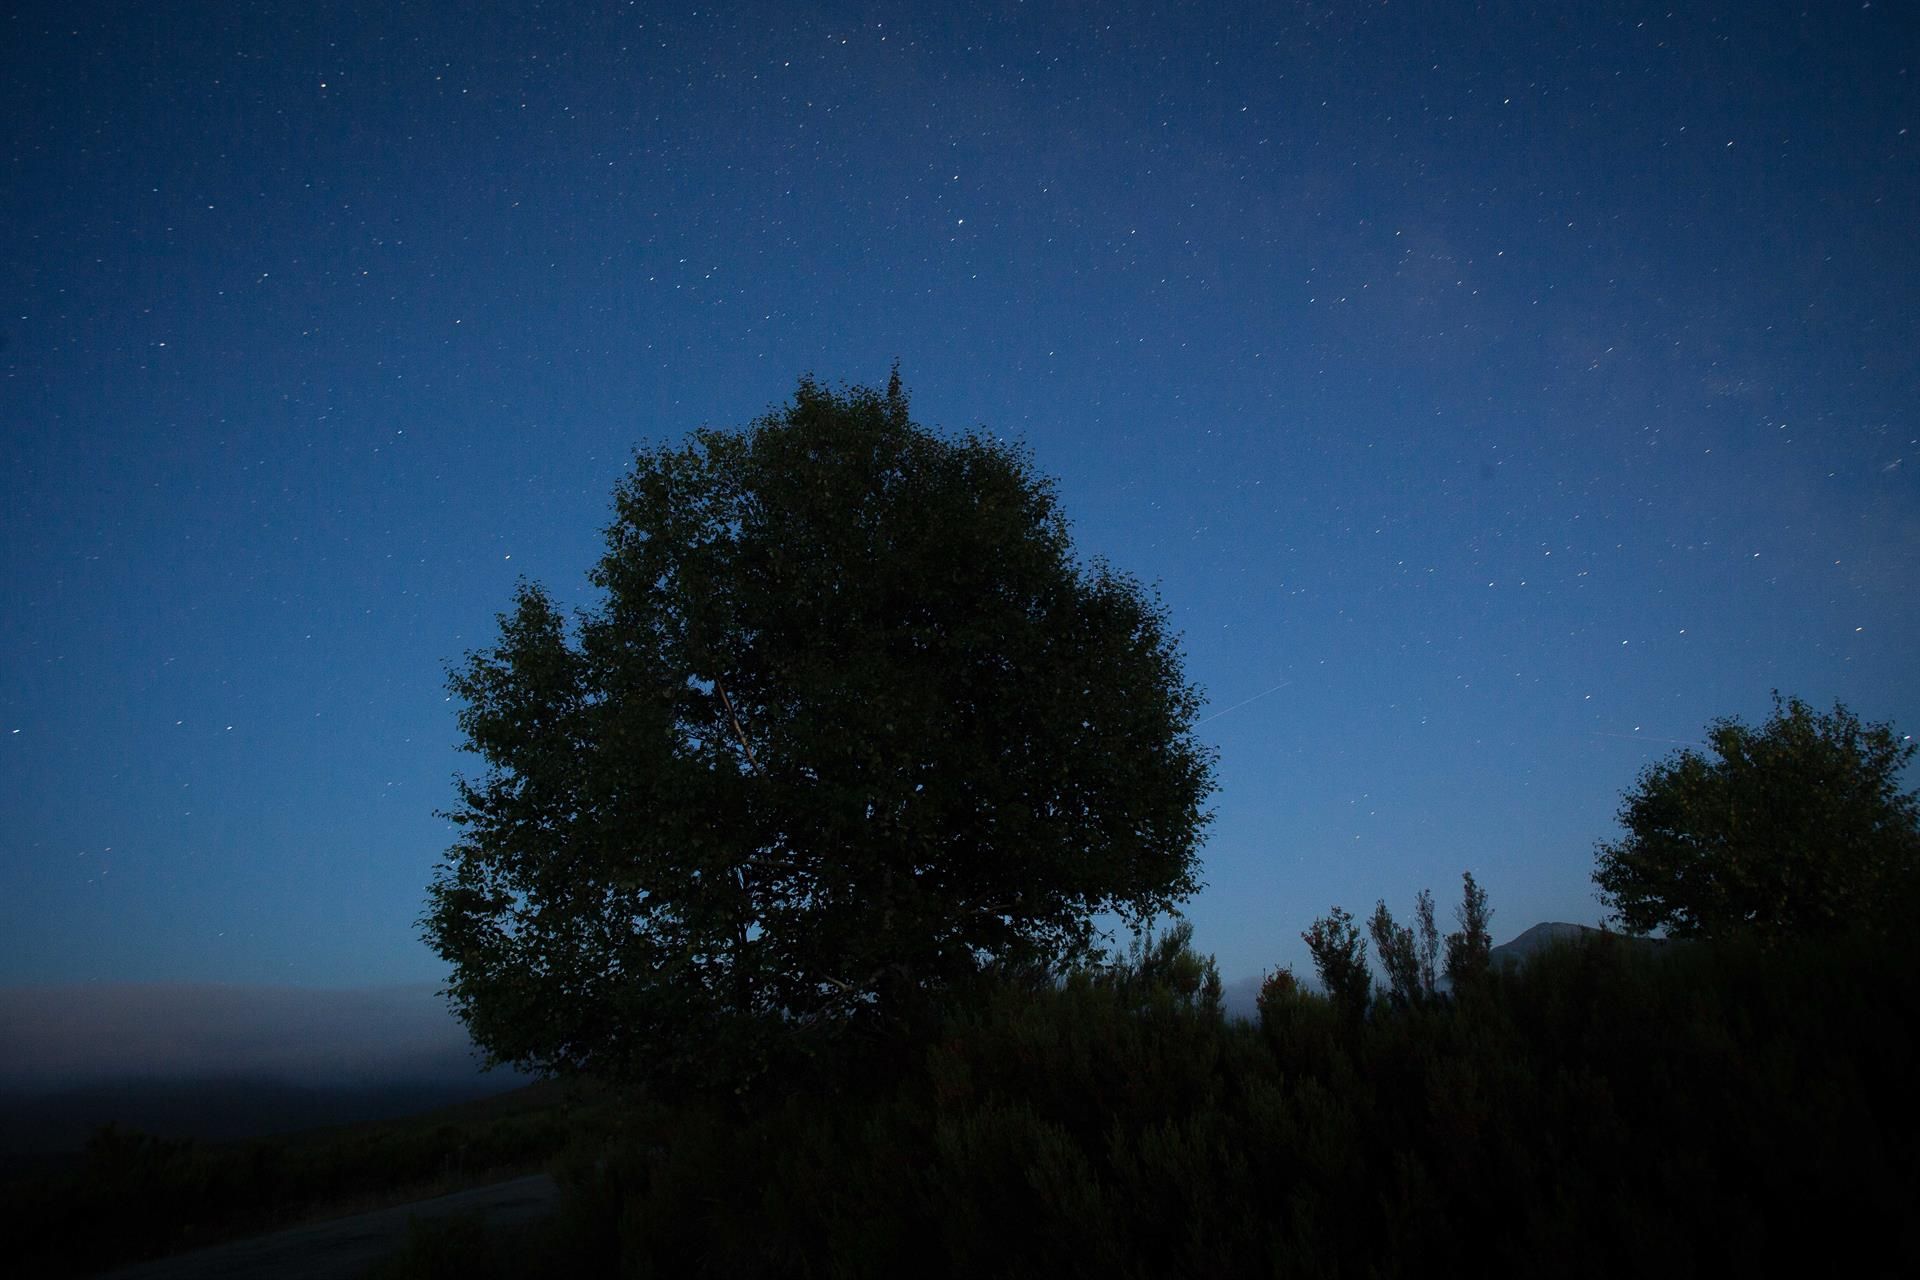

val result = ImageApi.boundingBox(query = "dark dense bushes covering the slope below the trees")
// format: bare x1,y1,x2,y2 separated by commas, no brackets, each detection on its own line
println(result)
389,917,1920,1276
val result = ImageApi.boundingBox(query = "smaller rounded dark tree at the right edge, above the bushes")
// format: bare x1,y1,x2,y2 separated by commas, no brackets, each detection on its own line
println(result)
1594,693,1920,938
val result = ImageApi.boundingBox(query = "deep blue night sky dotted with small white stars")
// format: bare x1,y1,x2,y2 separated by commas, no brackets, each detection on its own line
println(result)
0,0,1920,986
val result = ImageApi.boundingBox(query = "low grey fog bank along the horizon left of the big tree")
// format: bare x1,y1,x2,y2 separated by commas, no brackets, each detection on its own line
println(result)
0,983,513,1092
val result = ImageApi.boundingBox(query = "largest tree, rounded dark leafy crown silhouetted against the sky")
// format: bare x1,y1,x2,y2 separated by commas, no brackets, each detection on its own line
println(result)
433,376,1215,1082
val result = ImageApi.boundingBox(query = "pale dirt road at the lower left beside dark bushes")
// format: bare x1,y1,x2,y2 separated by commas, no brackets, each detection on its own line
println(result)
102,1173,561,1280
